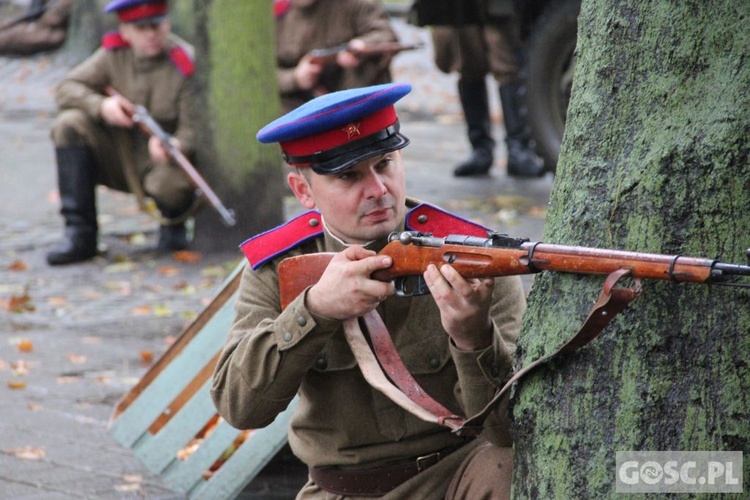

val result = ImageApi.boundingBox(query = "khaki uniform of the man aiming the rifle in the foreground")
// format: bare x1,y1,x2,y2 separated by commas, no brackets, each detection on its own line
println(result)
211,201,525,498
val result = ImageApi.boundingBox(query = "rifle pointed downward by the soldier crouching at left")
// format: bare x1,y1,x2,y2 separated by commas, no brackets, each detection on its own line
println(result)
104,86,237,226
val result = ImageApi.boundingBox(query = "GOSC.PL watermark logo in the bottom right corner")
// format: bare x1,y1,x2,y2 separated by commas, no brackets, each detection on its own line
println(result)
616,451,742,493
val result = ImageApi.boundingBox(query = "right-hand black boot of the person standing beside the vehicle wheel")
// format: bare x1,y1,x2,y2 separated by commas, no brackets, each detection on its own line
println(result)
500,83,546,177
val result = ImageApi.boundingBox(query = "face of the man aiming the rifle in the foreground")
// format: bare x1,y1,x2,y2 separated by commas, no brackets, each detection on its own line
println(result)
289,150,406,244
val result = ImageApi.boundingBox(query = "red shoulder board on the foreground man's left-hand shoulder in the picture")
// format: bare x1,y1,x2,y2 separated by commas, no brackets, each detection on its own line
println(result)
240,210,323,269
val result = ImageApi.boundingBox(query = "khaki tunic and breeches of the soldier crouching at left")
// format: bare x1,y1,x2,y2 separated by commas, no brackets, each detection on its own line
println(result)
52,31,197,211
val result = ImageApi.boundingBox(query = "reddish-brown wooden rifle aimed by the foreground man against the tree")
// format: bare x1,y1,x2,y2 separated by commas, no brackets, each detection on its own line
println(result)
278,232,750,309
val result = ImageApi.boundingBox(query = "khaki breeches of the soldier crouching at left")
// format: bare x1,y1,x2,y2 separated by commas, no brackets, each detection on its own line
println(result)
51,109,195,211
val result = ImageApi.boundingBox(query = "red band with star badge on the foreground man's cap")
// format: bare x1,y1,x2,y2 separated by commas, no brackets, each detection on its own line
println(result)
279,106,398,156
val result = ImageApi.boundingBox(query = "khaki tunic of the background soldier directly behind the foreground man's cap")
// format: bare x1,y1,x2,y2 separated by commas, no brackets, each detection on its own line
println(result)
276,0,398,111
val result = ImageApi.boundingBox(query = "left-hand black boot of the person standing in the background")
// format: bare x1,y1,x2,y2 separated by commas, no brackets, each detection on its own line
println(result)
453,78,495,177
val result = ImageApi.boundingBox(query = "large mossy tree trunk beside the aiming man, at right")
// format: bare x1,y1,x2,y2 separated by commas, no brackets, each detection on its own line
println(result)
513,0,750,498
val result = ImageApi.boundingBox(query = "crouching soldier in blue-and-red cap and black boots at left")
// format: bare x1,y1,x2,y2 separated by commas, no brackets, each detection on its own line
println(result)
47,0,196,265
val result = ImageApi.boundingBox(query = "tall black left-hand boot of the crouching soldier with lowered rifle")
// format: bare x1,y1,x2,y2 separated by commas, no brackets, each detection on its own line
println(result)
47,146,98,266
